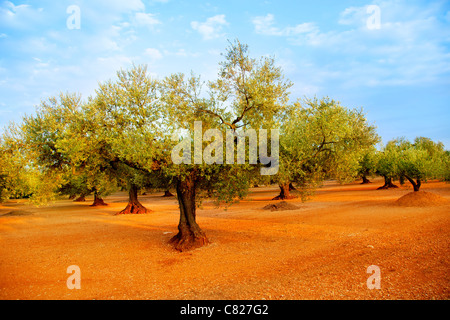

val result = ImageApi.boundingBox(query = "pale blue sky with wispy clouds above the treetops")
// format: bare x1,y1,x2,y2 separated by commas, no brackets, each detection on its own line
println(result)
0,0,450,149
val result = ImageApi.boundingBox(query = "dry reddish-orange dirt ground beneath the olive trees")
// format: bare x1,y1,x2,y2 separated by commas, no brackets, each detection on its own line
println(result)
0,180,450,300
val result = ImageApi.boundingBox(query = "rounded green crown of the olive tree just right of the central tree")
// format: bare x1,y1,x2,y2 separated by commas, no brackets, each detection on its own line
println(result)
277,97,379,196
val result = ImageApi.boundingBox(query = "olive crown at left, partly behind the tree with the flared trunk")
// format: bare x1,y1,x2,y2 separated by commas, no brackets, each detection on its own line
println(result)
21,93,120,204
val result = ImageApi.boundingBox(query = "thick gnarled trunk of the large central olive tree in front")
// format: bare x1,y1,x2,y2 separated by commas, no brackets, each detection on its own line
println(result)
170,173,208,251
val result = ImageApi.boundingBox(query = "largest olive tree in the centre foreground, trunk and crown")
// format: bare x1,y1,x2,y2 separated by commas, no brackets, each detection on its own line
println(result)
157,41,291,250
